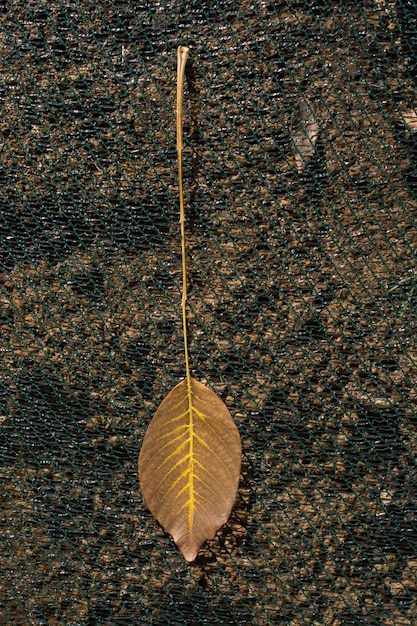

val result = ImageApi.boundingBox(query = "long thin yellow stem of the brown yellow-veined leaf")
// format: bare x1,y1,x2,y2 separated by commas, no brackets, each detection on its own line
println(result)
177,46,191,383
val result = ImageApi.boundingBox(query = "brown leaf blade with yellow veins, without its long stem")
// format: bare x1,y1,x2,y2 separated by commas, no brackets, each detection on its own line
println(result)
139,378,241,561
